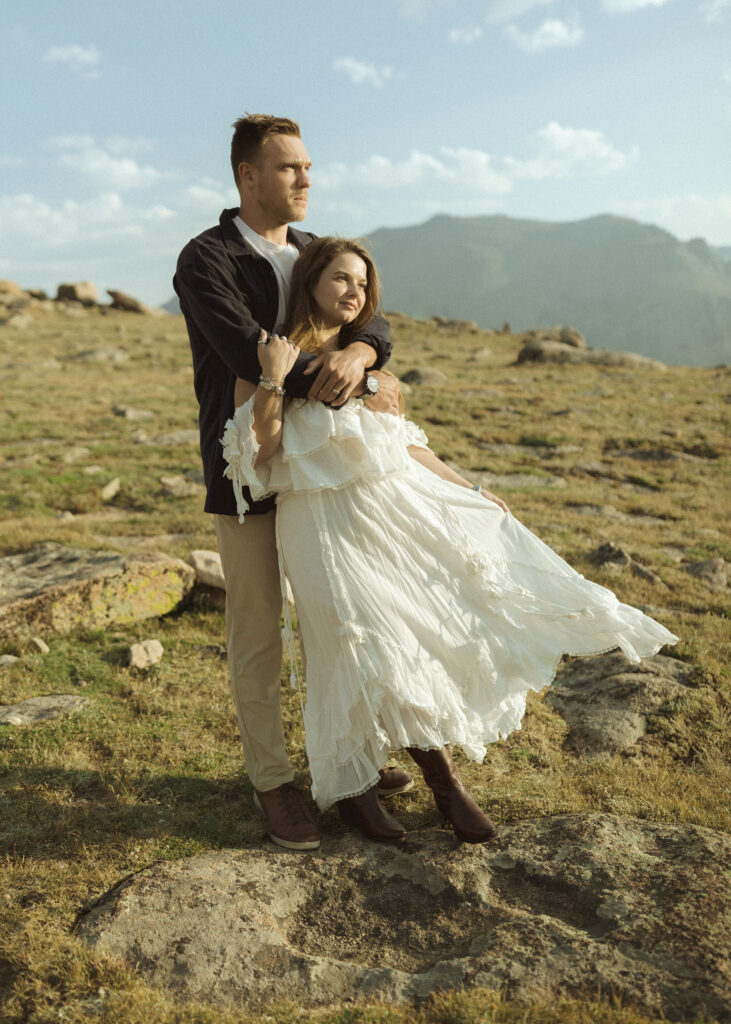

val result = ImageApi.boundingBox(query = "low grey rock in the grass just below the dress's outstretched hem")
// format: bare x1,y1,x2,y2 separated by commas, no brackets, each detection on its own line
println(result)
546,652,694,761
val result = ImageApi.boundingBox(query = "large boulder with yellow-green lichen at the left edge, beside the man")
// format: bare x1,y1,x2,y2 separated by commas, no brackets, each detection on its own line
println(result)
0,543,196,638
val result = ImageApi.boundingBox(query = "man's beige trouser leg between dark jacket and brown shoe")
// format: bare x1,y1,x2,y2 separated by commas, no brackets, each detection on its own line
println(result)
214,511,294,791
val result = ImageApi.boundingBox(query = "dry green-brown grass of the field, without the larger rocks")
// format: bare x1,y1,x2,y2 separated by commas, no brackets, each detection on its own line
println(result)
0,311,731,1024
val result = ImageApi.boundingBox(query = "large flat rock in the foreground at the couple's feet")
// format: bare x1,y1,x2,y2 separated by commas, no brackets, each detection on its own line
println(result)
72,814,731,1020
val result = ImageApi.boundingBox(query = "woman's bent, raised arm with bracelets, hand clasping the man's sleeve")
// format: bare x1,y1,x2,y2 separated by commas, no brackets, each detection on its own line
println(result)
233,331,300,466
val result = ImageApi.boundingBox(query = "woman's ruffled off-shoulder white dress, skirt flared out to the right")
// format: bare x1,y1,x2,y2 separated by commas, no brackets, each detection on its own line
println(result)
222,399,678,809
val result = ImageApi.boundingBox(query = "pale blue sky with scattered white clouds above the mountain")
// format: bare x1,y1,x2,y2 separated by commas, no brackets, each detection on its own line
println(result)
0,0,731,305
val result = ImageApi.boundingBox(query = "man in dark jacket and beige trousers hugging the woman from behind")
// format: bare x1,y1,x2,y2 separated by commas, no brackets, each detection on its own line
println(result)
173,115,412,850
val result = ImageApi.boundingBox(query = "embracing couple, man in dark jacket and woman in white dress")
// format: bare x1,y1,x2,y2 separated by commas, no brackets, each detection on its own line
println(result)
174,115,677,849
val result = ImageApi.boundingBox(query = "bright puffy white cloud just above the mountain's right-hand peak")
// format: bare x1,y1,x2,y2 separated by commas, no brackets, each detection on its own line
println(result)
506,121,638,181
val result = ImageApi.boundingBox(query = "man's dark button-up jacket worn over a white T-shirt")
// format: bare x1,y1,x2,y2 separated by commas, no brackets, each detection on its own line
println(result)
173,209,391,515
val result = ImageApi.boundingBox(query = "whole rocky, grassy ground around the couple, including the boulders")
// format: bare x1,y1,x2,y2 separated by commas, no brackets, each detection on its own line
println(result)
0,288,731,1024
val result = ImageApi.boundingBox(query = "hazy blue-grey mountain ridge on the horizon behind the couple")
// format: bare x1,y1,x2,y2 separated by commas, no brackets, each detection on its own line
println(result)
369,214,731,366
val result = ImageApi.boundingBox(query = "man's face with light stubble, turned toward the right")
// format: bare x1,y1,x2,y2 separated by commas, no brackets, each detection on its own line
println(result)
242,135,311,227
